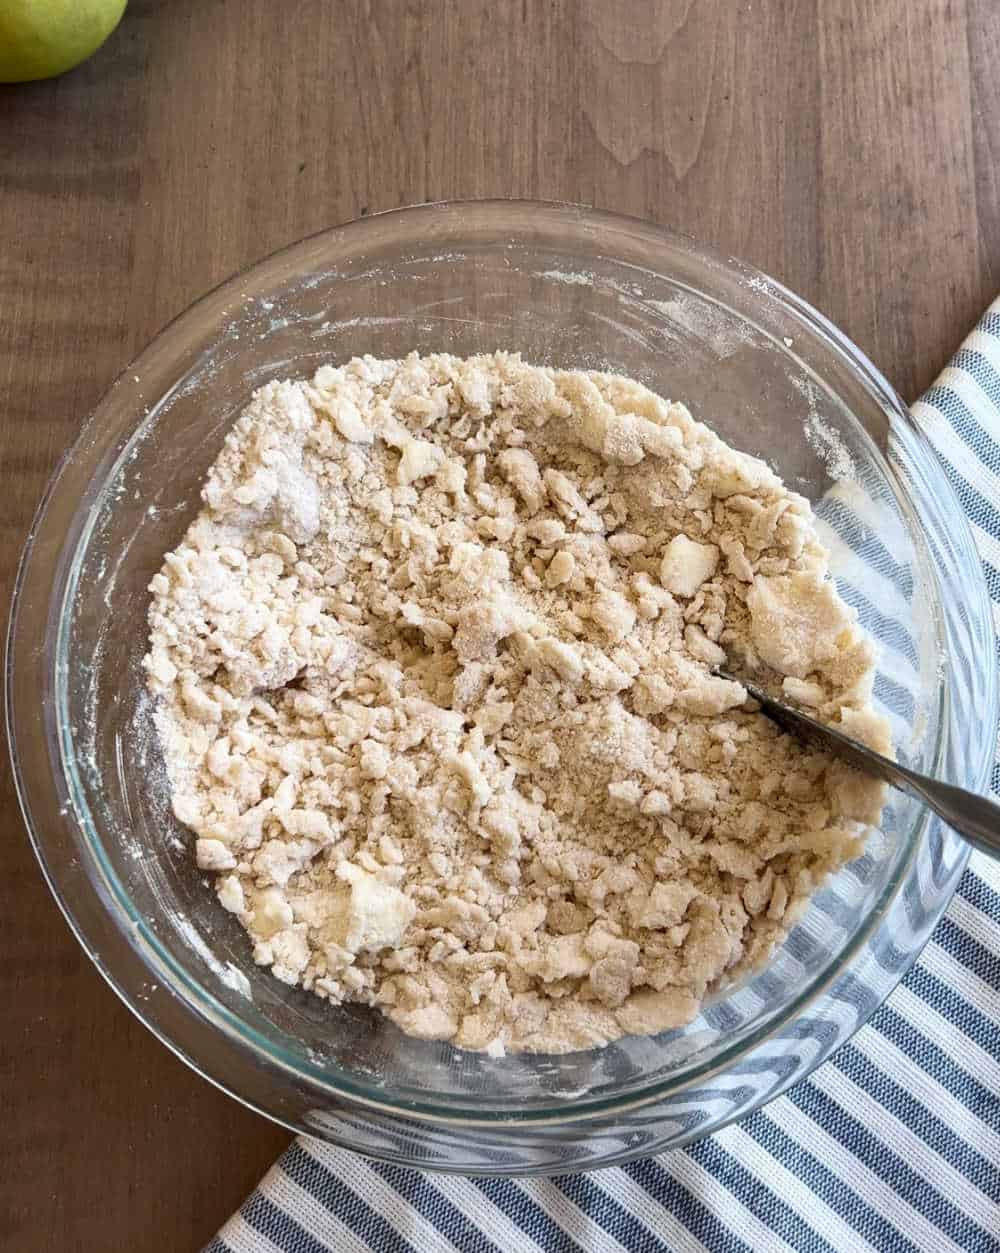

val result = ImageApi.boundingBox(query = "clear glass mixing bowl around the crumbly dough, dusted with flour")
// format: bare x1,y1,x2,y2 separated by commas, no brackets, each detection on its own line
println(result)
8,202,996,1174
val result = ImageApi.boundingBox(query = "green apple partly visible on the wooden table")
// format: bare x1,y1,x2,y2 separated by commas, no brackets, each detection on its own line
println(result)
0,0,127,83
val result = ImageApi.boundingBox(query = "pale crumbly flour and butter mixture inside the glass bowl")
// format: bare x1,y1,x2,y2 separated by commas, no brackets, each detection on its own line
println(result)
145,352,891,1055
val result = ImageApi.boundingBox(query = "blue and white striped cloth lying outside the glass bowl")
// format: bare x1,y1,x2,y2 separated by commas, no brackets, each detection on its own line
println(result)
207,299,1000,1253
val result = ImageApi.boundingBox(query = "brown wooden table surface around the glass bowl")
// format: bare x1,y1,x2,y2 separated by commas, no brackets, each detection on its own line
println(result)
0,0,1000,1253
